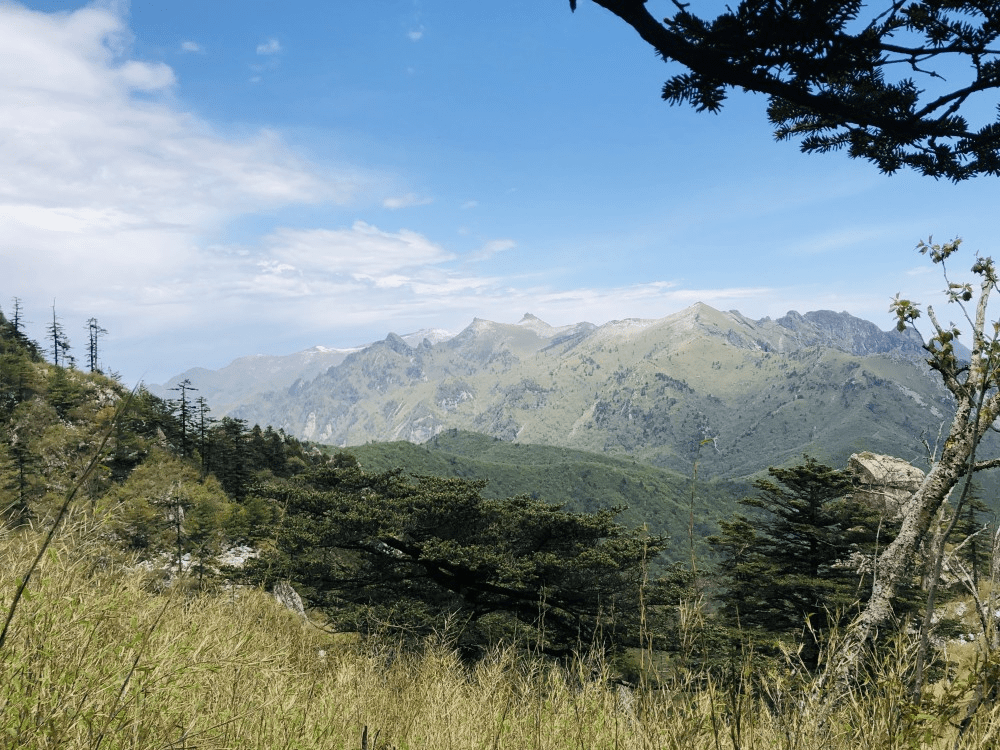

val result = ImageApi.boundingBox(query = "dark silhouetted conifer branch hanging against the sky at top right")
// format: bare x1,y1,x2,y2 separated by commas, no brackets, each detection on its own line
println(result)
570,0,1000,181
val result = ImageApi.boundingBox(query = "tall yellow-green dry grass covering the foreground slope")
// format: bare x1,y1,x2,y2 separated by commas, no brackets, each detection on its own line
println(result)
0,522,998,750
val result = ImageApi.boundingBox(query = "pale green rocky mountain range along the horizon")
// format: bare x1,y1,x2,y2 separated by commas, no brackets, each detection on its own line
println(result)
182,304,968,477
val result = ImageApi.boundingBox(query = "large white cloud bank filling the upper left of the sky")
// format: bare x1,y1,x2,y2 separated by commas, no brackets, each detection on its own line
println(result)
0,4,362,346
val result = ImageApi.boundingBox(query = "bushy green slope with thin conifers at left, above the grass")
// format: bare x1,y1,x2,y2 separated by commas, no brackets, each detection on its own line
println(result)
0,305,309,575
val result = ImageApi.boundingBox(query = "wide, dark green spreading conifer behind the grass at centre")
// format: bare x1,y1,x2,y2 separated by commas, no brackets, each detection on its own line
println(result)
253,467,664,653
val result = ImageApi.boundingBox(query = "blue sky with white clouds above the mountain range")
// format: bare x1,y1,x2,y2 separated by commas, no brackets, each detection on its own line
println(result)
0,0,1000,383
